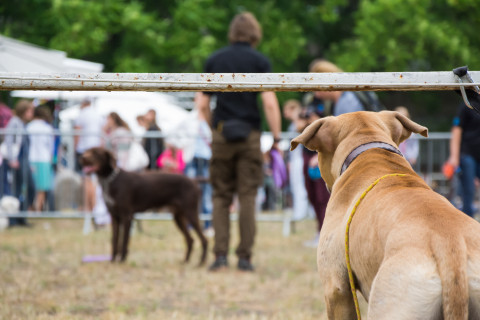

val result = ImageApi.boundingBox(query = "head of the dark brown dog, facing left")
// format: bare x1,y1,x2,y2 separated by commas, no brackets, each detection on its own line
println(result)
80,147,117,177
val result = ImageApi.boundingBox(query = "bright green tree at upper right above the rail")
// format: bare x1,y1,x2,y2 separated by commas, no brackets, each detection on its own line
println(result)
329,0,480,71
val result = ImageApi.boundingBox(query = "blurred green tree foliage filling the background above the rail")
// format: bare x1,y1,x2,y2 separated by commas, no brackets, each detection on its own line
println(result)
0,0,480,129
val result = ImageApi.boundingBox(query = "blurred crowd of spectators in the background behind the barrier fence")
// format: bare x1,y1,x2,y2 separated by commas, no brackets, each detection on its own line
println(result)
0,65,478,238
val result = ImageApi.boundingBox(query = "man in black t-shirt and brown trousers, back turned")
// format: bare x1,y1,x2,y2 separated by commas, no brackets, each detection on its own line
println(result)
198,12,281,271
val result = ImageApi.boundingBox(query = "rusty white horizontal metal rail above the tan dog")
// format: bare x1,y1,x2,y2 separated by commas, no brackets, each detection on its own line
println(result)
0,71,480,92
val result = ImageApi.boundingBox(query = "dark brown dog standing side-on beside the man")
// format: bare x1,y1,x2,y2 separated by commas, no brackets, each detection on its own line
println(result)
81,148,208,264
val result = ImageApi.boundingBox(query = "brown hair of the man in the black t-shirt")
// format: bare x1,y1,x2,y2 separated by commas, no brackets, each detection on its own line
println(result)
228,12,262,47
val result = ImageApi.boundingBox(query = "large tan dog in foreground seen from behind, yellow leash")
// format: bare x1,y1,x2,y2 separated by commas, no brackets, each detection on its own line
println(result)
291,111,480,320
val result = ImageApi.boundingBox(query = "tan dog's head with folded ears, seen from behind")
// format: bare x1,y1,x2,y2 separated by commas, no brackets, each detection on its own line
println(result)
291,111,428,190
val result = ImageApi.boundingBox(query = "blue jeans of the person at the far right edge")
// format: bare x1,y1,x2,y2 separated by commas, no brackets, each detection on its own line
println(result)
460,154,480,217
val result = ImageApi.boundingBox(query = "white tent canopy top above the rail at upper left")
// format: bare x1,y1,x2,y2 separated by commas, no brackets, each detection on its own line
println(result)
0,35,103,72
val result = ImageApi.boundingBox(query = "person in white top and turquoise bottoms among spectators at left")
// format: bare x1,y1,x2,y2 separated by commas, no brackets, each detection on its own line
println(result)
27,106,55,211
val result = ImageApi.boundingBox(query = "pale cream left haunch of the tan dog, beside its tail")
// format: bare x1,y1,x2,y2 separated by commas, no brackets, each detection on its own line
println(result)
368,250,443,320
